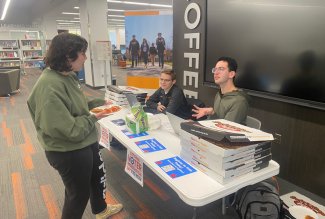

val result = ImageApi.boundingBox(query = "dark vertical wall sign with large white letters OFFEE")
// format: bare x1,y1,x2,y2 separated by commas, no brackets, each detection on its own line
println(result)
173,0,207,98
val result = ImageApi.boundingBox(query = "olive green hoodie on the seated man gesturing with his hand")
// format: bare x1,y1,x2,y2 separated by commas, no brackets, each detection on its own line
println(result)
209,90,249,124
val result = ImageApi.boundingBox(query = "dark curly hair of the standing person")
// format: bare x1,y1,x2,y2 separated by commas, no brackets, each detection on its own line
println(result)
45,33,88,72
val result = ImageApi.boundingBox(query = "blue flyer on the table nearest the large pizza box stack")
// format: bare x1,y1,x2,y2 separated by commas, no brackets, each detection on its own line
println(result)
156,156,196,178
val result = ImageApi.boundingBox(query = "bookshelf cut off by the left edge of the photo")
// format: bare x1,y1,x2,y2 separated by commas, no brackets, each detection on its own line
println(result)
0,40,21,69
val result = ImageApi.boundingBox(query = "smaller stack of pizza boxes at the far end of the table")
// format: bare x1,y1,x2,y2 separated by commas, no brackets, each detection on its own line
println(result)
105,85,147,106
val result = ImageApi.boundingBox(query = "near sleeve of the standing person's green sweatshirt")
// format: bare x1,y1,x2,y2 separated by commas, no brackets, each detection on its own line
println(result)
35,98,97,142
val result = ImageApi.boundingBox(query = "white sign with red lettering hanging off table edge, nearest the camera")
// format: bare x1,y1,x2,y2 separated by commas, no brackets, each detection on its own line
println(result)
125,150,143,187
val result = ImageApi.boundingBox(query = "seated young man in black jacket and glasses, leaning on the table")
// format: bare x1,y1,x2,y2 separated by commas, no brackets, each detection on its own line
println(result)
146,70,191,119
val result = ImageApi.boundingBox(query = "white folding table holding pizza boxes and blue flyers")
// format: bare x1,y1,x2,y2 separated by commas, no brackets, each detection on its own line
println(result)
99,109,280,211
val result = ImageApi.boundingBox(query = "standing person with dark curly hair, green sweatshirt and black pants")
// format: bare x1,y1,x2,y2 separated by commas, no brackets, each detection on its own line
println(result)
27,33,122,219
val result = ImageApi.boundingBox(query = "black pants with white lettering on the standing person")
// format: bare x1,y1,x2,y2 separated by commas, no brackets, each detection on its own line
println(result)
45,142,106,219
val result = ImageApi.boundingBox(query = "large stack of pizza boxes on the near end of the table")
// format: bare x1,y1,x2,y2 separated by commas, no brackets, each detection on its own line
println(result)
180,119,273,184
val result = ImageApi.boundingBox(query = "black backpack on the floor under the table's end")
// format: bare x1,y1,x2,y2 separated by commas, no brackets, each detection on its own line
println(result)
232,178,282,219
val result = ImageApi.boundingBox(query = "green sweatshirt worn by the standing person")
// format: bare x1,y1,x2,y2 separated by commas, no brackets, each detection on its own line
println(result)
27,68,105,152
